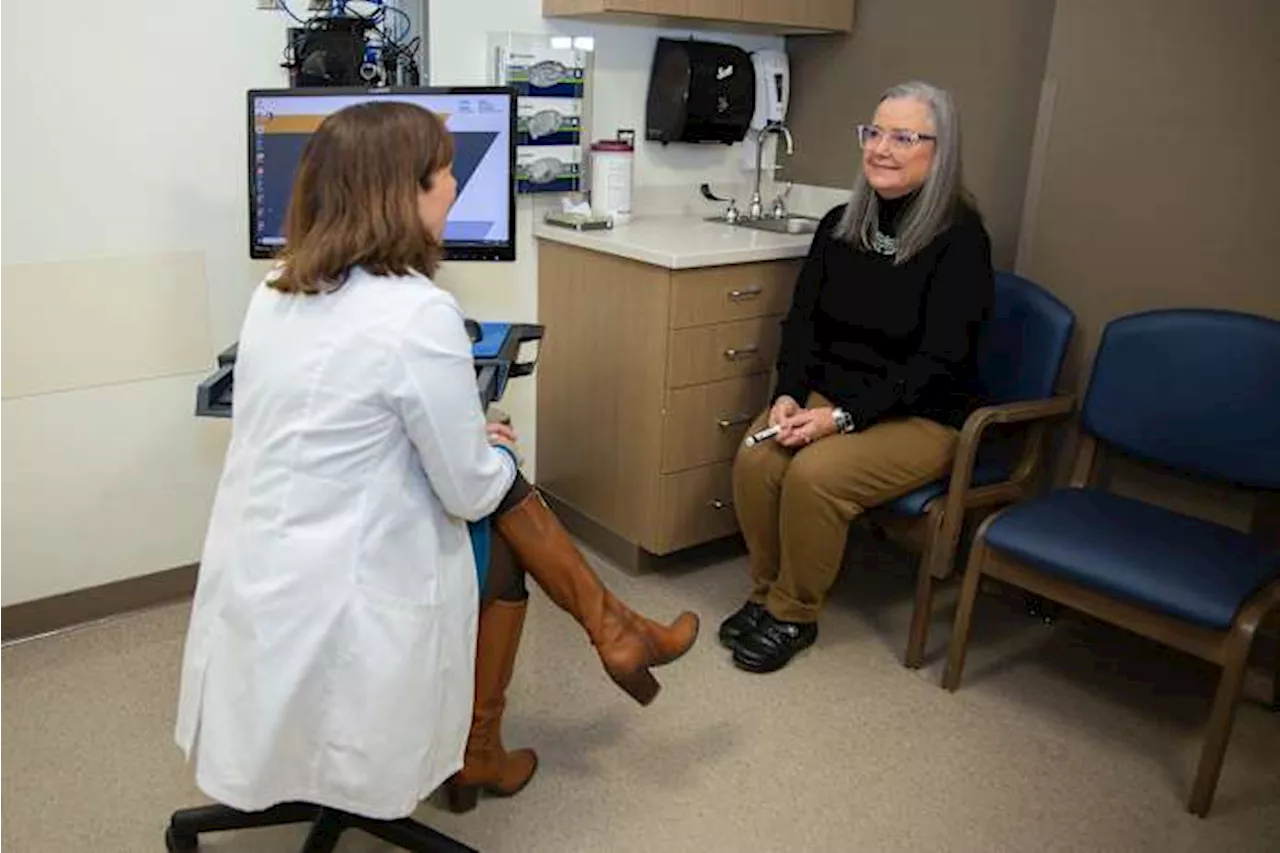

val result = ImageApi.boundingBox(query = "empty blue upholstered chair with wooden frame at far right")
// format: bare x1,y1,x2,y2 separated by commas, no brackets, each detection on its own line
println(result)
943,310,1280,817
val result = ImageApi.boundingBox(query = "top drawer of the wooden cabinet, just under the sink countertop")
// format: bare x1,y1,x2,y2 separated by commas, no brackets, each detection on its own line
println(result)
671,261,800,329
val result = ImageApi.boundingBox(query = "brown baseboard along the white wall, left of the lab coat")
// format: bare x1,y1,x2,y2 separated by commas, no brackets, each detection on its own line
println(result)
0,564,200,646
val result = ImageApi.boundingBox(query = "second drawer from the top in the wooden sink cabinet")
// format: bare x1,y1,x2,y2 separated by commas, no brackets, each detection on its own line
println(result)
667,315,782,388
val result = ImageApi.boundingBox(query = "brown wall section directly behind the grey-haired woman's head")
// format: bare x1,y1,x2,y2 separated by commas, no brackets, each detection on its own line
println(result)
786,0,1053,266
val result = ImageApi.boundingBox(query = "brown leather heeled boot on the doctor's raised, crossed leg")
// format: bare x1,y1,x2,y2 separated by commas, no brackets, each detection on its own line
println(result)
494,489,698,704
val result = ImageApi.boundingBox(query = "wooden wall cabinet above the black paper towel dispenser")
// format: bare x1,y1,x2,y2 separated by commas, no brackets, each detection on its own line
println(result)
543,0,856,32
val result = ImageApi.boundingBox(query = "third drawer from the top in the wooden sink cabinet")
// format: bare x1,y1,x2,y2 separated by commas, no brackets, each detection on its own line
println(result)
662,375,769,474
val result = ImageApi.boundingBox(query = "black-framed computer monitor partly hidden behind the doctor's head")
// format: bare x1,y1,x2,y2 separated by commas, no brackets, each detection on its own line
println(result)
248,86,516,261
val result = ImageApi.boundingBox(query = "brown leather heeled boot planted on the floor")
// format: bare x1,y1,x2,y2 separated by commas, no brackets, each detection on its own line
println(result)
447,601,538,812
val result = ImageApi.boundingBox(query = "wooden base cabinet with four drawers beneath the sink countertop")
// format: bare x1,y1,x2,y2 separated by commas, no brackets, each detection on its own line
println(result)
538,241,800,556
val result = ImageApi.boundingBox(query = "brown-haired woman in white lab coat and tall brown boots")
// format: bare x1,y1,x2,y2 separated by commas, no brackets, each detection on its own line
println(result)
177,104,698,818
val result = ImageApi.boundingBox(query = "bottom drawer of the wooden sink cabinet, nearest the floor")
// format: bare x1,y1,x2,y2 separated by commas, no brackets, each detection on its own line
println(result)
653,462,737,553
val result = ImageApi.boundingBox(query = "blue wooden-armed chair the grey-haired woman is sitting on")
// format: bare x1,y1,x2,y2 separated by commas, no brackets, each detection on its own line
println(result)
872,273,1075,669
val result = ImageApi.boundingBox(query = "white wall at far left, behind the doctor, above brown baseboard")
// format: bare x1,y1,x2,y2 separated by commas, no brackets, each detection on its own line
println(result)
0,0,289,612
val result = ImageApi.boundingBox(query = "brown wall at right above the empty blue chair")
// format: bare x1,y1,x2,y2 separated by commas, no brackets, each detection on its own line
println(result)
1020,0,1280,524
